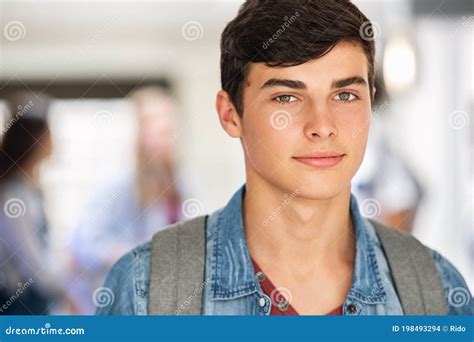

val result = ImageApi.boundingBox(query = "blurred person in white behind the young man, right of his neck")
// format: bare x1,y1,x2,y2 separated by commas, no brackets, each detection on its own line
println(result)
352,72,423,231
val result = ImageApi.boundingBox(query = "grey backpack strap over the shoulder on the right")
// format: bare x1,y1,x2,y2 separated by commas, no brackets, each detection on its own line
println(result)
369,220,448,315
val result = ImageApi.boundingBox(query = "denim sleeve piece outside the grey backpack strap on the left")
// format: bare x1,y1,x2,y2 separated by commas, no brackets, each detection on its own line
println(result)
93,242,151,315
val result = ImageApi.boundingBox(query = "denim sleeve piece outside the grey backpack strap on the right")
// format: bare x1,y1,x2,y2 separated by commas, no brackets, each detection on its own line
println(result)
430,249,474,315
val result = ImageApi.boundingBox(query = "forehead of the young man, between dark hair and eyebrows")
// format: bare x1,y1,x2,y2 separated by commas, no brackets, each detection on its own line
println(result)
247,42,368,87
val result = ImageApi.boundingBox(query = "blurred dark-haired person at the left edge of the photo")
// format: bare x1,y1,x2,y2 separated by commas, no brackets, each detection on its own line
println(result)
0,93,70,315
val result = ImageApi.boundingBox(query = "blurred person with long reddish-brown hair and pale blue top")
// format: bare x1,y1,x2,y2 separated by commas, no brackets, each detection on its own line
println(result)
73,86,183,313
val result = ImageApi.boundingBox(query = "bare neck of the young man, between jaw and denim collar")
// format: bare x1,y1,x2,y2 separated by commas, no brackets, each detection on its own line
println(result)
243,175,355,270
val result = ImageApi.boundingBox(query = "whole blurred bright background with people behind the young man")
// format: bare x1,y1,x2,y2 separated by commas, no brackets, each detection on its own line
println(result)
0,0,474,314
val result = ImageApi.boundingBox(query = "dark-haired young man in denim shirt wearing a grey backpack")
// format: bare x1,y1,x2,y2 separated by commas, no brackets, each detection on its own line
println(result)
98,0,473,315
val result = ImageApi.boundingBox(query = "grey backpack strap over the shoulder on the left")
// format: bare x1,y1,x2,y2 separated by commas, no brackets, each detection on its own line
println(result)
148,216,207,315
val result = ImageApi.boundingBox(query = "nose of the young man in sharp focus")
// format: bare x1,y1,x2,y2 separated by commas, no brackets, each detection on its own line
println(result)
304,108,338,141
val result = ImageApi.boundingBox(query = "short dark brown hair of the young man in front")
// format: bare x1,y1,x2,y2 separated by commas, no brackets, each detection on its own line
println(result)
221,0,375,115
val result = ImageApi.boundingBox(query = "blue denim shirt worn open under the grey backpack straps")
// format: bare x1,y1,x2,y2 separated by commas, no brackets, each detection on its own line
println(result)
96,185,474,315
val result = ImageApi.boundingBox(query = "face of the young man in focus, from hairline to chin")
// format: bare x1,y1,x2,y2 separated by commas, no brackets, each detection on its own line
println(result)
221,43,371,199
